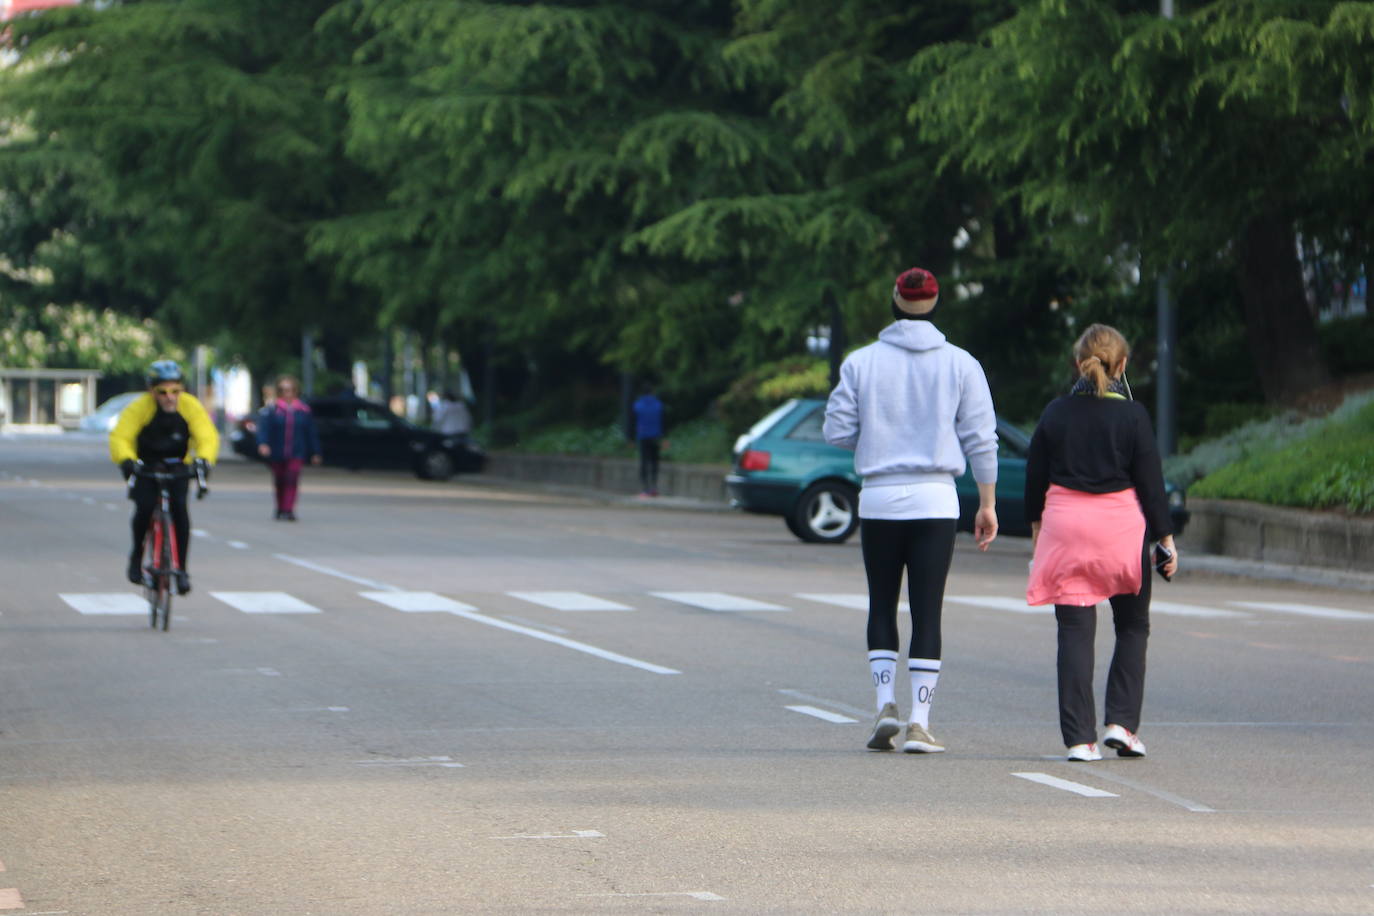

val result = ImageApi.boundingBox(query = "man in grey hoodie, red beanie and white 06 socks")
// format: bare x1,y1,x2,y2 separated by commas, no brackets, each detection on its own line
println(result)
822,268,998,754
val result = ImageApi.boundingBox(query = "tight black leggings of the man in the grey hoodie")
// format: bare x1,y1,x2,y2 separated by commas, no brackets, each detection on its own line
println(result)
859,519,955,659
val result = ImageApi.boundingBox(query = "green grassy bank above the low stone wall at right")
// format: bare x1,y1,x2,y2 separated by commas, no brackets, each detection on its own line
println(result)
1190,398,1374,514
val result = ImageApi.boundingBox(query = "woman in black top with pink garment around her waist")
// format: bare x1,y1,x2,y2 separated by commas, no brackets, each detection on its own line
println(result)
1025,324,1179,761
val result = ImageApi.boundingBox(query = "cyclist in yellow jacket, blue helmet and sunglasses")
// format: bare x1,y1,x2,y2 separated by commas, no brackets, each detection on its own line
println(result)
110,360,220,595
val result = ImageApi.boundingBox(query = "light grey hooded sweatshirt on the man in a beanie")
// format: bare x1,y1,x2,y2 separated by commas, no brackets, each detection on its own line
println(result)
823,320,998,486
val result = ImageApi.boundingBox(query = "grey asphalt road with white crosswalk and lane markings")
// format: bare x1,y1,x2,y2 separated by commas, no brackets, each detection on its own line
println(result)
0,437,1374,916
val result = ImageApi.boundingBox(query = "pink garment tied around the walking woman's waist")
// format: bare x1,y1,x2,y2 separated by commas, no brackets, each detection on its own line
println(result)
1026,483,1145,607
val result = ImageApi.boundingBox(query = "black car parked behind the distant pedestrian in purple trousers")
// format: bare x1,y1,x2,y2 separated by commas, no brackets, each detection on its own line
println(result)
229,397,486,481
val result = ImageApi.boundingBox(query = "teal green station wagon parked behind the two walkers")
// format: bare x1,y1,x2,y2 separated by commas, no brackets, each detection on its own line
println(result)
725,398,1189,544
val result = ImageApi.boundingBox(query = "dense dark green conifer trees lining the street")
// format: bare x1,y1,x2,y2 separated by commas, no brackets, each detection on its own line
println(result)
0,0,1374,439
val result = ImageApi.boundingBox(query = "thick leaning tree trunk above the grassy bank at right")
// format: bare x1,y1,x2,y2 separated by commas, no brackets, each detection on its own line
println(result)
1237,213,1331,404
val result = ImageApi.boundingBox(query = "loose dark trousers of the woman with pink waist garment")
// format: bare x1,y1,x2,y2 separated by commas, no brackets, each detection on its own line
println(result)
1054,544,1150,747
